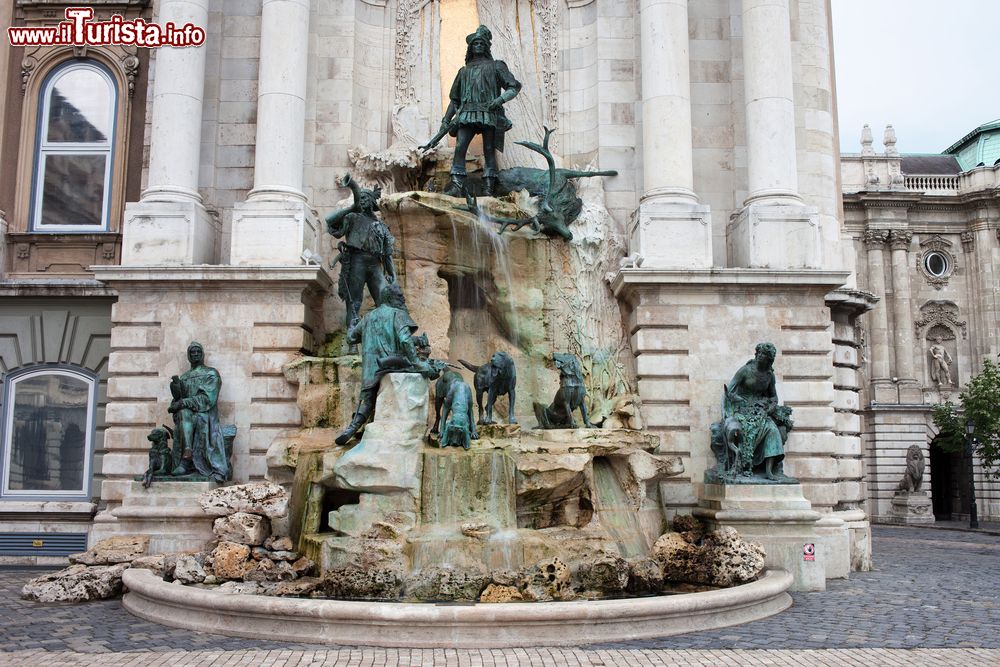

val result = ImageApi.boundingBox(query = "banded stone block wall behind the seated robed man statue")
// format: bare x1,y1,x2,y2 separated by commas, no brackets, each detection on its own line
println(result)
94,267,321,509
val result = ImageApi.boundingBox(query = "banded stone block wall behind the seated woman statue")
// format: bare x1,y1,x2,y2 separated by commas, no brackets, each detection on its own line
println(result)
615,270,857,512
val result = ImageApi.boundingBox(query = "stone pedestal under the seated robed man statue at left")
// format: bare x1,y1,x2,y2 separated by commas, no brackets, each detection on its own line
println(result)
88,482,218,554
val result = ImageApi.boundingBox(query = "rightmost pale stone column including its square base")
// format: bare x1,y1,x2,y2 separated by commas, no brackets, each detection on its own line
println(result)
727,0,823,269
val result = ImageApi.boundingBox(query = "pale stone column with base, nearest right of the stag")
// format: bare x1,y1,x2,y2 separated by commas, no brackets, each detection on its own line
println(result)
630,0,712,268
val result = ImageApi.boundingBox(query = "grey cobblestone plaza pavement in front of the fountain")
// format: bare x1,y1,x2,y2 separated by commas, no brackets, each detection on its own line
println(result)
0,526,1000,667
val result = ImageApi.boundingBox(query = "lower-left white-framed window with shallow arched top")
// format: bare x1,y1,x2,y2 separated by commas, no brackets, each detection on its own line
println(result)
2,366,97,498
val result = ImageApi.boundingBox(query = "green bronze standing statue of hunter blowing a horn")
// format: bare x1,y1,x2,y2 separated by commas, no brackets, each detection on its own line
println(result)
326,174,396,326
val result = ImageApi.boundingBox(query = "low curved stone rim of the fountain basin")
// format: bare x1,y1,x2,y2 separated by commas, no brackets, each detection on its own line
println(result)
124,569,792,648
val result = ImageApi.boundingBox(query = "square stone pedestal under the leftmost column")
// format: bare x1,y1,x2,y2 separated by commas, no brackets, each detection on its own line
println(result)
122,200,219,266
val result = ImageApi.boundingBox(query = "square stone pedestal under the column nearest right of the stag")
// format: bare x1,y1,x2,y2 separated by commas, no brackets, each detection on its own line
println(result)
629,200,712,269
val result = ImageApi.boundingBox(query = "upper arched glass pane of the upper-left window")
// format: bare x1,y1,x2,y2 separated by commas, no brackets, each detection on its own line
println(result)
46,68,111,143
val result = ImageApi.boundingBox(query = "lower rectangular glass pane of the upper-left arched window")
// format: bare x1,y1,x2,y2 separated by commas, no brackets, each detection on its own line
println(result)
41,155,107,225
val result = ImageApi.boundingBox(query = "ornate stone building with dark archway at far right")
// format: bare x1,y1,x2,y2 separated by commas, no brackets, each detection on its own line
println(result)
841,121,1000,521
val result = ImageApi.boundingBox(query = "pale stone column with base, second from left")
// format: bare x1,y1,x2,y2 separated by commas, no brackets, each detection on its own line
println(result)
230,0,320,265
